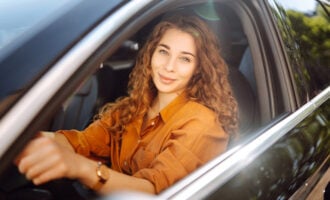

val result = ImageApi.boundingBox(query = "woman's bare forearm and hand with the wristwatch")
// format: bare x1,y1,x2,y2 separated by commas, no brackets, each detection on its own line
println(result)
17,132,155,194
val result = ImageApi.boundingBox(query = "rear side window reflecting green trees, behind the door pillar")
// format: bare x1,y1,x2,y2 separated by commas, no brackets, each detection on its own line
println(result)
269,0,330,103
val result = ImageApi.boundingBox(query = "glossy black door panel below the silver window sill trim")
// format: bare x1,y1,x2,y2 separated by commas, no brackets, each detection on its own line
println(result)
206,100,330,199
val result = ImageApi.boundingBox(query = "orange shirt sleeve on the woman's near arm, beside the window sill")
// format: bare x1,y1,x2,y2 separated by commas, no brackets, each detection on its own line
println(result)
133,111,228,193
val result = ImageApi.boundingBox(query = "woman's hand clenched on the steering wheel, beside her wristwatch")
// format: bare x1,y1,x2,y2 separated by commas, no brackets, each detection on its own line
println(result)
16,134,84,185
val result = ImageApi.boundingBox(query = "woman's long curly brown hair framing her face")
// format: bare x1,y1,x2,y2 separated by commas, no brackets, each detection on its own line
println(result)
100,16,238,136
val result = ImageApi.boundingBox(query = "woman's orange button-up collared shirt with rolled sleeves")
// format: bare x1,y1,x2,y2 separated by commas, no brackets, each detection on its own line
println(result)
58,95,228,193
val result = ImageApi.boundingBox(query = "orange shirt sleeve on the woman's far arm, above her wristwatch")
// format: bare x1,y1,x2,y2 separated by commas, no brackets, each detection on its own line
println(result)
57,115,110,157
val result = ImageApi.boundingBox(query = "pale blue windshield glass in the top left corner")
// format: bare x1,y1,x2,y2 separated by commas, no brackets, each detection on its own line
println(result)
0,0,79,52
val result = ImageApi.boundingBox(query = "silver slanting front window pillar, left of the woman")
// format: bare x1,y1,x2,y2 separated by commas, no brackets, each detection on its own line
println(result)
0,1,151,173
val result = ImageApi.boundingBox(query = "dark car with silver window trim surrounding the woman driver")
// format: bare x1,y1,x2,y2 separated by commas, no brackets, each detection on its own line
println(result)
0,0,330,199
